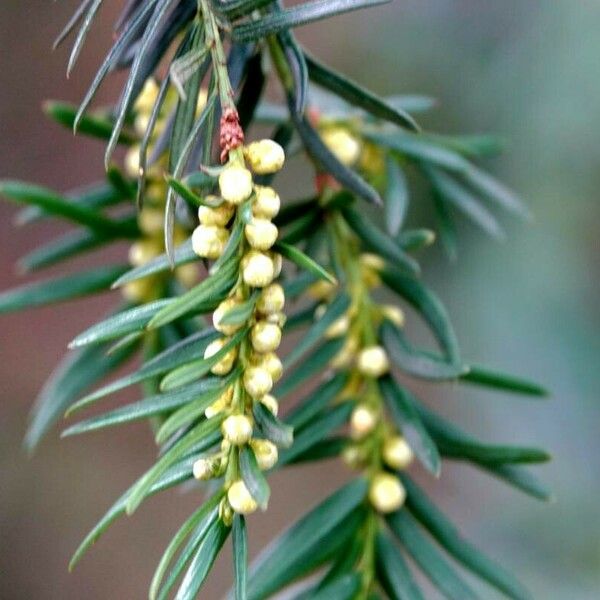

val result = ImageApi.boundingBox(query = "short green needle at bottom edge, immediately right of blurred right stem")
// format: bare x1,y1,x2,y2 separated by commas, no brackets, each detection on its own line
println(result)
376,531,424,600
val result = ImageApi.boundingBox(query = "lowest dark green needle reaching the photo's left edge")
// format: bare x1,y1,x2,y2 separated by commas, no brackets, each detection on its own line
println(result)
0,266,127,314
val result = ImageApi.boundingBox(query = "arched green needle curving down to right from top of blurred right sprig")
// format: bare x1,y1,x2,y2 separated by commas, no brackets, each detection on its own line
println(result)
380,266,460,364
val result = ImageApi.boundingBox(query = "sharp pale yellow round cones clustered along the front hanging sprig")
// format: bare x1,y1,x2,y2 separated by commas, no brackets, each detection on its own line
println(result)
192,140,285,521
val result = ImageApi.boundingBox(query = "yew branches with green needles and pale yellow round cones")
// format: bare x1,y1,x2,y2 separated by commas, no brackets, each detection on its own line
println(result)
0,0,550,600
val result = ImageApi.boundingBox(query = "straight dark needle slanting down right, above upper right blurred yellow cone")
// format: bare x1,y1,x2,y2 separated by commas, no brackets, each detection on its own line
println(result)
306,54,419,131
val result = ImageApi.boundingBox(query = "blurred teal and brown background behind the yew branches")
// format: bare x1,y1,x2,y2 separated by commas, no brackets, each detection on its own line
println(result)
0,0,600,600
